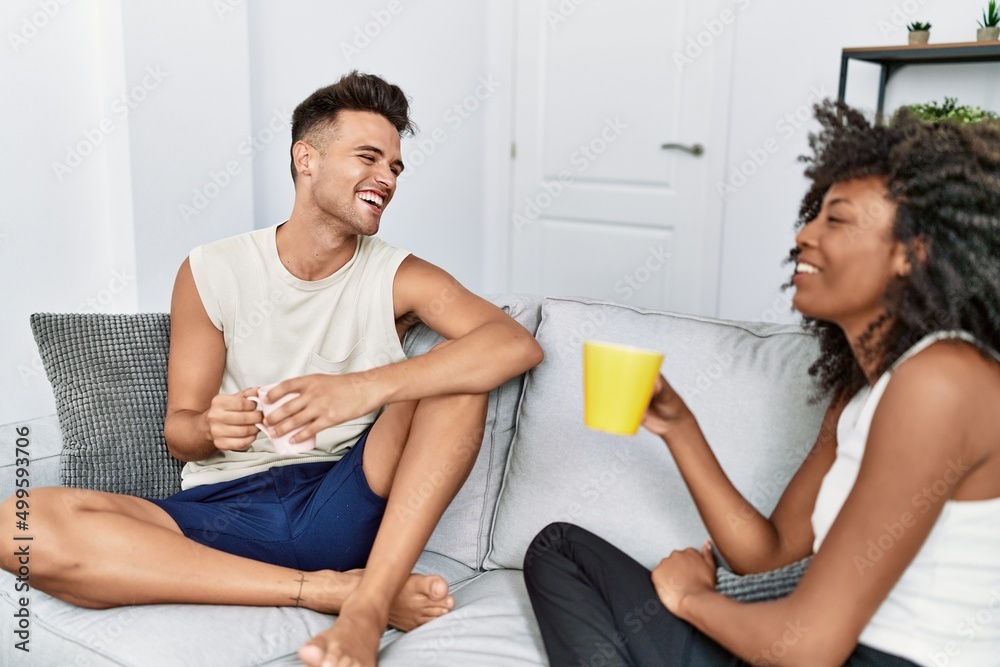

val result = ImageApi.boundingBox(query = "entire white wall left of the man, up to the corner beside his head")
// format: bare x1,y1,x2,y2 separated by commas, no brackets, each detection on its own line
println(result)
0,0,253,423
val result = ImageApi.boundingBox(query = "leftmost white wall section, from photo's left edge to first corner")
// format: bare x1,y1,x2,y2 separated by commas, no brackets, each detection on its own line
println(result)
0,0,124,423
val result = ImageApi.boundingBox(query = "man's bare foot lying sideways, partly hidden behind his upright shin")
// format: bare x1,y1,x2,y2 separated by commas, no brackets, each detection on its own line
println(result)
301,570,455,631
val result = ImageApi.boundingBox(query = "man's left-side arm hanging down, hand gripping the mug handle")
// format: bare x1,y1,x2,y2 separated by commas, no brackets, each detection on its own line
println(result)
163,259,262,461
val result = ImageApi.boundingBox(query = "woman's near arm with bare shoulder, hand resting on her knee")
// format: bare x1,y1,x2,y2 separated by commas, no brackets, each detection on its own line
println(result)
653,346,984,666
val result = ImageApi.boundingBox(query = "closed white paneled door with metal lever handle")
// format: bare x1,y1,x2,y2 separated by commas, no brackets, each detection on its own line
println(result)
510,0,739,315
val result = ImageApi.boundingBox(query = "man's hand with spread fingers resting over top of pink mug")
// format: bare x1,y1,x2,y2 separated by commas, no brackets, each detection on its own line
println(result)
257,373,385,444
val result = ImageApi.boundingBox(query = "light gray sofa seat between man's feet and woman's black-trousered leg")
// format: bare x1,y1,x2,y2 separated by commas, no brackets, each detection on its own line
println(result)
378,570,549,667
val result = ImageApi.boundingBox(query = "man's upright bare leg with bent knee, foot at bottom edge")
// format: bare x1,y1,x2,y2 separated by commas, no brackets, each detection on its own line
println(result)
299,394,487,667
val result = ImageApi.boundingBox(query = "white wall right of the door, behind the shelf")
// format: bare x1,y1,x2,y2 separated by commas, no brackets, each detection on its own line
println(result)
719,0,1000,321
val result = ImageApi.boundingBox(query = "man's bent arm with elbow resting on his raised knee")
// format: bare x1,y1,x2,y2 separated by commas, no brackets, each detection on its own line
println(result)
266,255,542,441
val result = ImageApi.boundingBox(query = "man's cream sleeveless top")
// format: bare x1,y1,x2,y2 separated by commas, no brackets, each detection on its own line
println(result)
182,226,409,489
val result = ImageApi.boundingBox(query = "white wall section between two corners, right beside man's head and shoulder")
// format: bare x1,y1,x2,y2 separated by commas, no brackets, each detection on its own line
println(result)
122,0,253,312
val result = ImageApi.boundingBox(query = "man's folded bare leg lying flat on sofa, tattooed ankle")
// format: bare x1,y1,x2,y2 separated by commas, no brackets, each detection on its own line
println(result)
0,487,450,629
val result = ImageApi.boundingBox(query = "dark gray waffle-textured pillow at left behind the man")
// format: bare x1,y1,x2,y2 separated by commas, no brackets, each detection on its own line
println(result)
31,313,181,498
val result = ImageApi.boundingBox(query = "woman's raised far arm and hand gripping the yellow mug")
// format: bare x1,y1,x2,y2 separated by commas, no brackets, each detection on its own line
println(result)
643,377,843,574
